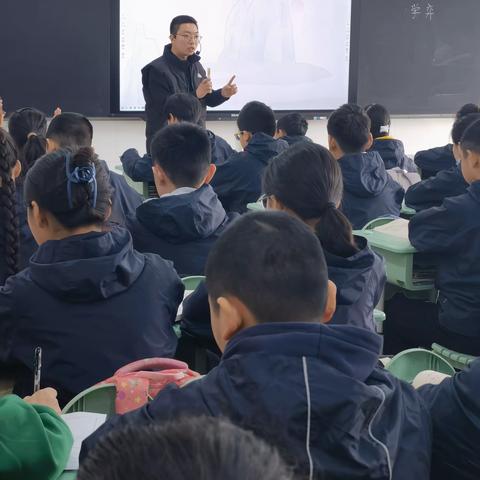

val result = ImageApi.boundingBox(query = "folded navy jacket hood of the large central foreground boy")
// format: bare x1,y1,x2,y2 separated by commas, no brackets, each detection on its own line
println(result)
222,323,382,381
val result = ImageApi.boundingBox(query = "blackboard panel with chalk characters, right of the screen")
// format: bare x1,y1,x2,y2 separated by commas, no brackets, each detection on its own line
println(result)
353,0,480,114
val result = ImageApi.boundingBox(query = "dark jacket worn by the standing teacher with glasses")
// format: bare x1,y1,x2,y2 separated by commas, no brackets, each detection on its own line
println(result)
142,45,227,152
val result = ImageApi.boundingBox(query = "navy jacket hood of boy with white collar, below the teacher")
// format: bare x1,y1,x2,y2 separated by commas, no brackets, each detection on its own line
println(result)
137,185,228,243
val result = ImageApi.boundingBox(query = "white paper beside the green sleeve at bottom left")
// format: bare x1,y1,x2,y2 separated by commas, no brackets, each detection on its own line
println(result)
62,412,107,470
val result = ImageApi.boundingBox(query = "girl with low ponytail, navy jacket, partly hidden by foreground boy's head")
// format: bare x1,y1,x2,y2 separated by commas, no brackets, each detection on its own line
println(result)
263,143,386,330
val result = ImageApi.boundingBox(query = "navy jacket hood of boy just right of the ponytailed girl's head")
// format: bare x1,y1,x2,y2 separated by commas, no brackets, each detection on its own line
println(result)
338,152,388,197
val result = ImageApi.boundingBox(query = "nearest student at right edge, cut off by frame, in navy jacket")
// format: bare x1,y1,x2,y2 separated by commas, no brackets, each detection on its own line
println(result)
385,120,480,356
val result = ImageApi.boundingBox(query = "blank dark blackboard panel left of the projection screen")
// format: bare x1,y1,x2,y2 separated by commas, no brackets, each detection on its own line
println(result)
0,0,112,116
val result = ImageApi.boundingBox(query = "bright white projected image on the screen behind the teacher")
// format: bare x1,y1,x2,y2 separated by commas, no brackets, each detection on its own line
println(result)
120,0,351,111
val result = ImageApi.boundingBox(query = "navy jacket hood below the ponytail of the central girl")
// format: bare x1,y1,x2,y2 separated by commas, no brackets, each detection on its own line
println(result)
324,236,380,306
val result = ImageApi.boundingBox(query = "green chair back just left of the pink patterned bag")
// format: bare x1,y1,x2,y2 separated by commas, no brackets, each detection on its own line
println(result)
62,385,117,416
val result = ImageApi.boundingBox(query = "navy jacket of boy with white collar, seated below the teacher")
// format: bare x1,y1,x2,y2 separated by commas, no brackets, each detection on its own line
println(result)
128,185,238,276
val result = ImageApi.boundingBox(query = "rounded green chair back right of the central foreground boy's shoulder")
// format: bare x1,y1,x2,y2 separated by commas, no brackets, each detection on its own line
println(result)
385,348,455,383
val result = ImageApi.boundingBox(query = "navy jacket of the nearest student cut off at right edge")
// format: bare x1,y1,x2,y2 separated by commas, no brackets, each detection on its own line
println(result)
409,181,480,341
